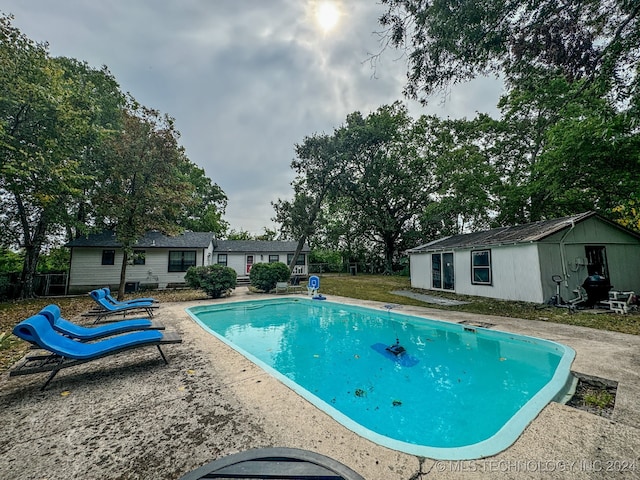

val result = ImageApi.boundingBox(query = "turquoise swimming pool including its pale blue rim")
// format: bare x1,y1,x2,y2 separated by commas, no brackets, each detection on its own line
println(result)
187,298,575,460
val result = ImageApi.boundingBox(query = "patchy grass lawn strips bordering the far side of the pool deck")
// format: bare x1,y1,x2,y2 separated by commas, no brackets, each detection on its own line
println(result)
0,274,640,372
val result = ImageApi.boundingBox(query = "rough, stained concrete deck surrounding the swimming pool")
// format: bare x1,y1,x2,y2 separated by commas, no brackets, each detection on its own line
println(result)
0,288,640,480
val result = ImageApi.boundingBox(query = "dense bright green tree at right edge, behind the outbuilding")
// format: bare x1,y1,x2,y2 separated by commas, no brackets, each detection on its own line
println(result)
531,92,640,218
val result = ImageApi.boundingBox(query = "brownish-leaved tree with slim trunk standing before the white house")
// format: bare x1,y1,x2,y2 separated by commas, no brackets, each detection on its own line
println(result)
93,102,198,298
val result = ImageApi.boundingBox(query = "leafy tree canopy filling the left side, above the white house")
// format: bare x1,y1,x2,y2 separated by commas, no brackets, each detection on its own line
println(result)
0,15,227,297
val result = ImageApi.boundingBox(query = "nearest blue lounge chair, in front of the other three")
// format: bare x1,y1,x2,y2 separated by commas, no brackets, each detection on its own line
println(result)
9,315,182,390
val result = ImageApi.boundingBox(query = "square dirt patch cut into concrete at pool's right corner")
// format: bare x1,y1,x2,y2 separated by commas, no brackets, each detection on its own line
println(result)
567,372,618,418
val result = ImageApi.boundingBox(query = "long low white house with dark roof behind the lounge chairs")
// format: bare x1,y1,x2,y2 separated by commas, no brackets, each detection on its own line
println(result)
66,232,309,293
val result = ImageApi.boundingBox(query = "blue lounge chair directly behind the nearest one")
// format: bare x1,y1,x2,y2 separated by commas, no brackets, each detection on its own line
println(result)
39,304,164,342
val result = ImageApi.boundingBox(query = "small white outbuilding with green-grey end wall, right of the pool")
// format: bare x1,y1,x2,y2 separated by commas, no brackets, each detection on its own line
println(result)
407,212,640,303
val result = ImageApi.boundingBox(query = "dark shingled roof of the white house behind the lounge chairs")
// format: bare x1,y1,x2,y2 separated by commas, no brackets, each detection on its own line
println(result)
65,231,213,248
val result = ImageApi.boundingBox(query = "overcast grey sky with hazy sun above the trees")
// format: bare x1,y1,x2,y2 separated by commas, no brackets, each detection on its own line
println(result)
6,0,501,234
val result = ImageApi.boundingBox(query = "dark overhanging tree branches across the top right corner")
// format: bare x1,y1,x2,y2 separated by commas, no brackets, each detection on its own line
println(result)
380,0,640,103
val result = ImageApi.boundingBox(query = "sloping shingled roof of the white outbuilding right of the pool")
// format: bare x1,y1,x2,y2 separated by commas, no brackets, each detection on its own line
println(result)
408,212,597,253
